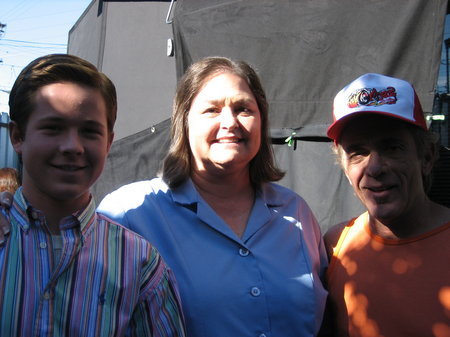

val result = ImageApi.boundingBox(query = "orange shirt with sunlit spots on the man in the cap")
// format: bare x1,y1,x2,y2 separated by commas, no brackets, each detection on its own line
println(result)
327,212,450,337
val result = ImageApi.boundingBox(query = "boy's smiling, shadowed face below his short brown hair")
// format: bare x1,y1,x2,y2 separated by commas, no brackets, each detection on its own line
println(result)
11,82,113,209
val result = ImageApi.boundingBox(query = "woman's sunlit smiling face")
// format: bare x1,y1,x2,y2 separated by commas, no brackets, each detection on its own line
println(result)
188,73,261,172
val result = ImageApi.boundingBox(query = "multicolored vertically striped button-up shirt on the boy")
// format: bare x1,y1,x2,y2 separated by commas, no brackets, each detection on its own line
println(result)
0,189,184,337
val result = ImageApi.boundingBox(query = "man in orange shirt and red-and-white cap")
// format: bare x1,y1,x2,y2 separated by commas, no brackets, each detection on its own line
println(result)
325,74,450,337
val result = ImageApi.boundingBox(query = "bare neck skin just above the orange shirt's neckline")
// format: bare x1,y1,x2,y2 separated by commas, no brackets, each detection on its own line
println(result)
369,198,450,239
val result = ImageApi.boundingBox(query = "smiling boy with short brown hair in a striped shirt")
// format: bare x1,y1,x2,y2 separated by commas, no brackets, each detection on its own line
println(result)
0,54,184,337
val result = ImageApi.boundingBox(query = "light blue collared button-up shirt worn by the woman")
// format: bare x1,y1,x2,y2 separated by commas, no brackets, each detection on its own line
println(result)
98,179,327,337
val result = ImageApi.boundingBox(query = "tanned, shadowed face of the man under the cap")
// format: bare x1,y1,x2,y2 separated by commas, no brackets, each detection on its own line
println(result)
339,116,428,223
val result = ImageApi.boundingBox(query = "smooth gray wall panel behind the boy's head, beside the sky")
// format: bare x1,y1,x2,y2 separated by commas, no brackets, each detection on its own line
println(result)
68,0,176,140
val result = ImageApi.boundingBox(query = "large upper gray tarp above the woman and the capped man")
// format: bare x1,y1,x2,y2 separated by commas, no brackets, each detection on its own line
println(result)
173,0,447,136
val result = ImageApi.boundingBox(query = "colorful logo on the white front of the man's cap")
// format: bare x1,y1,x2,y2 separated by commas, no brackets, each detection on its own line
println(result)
347,87,397,108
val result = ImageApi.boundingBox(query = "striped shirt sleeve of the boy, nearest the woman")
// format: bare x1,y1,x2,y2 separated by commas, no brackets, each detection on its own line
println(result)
131,247,186,337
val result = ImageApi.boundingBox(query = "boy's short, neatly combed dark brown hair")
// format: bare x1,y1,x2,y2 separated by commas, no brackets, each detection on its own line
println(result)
9,54,117,137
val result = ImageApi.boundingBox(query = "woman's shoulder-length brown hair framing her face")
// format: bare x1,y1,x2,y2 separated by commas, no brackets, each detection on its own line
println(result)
162,57,284,188
